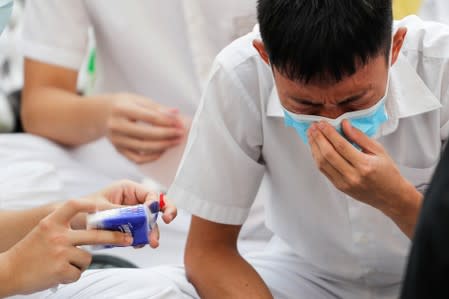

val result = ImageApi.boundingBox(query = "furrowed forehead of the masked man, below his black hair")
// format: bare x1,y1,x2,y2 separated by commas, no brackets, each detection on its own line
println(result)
274,56,387,101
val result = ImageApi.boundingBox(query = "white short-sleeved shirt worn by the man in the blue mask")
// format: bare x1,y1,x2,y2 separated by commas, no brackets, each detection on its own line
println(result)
169,17,449,286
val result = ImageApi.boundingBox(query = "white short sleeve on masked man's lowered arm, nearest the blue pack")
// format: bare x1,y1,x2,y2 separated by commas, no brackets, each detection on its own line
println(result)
168,58,265,225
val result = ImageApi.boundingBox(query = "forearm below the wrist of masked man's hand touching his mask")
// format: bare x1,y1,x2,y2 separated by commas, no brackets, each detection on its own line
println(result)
383,182,424,239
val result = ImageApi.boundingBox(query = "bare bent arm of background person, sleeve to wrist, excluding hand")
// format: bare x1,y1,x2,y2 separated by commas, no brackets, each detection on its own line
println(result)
22,59,114,146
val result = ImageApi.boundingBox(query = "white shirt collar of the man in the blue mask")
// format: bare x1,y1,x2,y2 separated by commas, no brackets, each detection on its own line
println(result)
267,54,442,135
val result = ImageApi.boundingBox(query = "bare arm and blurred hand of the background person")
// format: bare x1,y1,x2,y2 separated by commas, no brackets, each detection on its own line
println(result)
21,59,187,164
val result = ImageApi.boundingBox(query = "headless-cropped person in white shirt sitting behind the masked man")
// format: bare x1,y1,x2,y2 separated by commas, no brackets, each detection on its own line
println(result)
15,0,271,265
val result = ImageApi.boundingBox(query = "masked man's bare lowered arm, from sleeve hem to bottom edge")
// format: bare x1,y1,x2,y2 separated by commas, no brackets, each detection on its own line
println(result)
185,216,272,298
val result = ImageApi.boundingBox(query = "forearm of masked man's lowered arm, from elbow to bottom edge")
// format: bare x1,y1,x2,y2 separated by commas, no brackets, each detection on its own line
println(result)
186,247,272,299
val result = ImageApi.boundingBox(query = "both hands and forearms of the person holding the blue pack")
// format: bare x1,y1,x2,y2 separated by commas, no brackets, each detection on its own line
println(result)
0,181,176,297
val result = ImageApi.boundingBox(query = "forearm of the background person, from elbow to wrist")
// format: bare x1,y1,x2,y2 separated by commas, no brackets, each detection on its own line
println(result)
22,87,114,146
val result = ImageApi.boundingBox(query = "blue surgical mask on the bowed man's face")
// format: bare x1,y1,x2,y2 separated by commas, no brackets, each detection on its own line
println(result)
284,77,390,144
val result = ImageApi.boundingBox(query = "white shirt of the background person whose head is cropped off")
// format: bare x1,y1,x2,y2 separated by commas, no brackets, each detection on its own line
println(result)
21,0,256,182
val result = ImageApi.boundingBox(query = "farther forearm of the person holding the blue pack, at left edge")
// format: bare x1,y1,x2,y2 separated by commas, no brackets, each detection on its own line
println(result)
0,204,58,253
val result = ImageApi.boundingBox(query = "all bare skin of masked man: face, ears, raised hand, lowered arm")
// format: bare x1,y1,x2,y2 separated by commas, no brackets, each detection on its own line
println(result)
185,28,423,298
